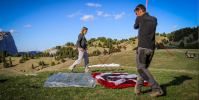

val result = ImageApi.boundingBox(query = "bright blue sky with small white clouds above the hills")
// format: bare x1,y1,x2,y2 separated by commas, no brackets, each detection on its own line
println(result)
0,0,198,52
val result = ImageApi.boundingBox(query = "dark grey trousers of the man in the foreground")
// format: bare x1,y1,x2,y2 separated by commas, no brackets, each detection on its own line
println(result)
136,47,161,91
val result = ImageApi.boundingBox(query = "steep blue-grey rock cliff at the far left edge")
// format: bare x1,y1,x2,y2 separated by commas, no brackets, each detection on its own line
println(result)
0,32,18,55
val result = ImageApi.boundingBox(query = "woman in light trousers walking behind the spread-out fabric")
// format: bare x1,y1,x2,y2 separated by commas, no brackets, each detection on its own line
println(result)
68,27,91,73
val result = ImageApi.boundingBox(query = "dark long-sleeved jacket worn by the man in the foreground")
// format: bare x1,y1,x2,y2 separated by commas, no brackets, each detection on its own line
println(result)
134,13,157,50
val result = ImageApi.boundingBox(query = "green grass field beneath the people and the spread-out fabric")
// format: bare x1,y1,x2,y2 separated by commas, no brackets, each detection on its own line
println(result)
0,49,199,100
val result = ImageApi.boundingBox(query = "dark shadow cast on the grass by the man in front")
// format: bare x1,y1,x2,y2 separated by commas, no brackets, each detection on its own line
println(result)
143,75,192,96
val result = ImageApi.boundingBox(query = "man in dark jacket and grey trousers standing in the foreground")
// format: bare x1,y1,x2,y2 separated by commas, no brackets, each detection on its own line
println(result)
134,4,163,97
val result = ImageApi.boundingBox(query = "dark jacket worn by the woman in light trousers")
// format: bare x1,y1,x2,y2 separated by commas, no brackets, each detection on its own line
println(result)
77,33,87,49
